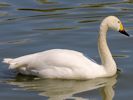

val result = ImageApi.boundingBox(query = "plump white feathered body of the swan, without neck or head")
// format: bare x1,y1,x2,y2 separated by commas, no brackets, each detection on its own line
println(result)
3,49,106,79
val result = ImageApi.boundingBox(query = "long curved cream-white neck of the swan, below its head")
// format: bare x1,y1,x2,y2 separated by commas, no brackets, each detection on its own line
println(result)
98,21,116,75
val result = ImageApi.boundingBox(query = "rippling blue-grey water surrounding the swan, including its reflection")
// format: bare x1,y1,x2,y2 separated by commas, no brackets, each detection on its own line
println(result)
0,0,133,100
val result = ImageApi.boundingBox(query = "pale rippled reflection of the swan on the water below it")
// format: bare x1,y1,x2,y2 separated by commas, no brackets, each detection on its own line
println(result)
8,75,117,100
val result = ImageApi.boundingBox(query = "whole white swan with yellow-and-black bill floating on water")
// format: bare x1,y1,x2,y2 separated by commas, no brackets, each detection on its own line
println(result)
3,16,129,80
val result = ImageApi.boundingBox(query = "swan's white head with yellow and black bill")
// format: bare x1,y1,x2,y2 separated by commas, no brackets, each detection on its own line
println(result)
104,16,129,36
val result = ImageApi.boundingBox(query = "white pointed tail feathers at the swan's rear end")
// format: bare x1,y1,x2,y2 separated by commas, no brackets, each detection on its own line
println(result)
2,58,26,69
